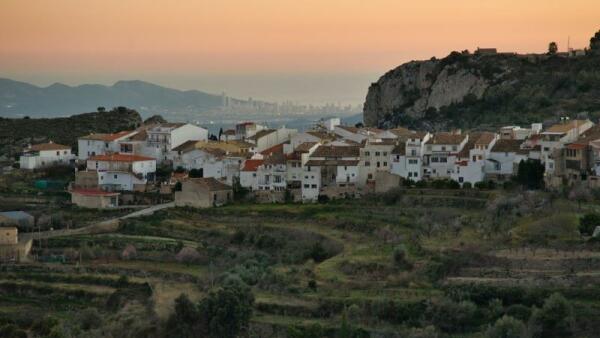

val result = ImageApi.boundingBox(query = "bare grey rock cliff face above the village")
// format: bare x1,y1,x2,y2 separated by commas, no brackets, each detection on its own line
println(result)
364,55,489,127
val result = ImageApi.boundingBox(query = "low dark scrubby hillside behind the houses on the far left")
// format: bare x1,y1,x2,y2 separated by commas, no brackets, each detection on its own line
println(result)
0,107,142,156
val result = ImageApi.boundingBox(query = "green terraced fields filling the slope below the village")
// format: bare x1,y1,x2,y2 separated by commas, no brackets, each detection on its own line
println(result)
0,190,600,337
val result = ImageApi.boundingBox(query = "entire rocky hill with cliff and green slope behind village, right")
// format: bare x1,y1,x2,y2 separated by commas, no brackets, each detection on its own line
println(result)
364,33,600,130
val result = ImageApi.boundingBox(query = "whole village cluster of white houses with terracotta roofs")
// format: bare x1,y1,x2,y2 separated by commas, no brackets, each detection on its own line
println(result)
21,118,600,208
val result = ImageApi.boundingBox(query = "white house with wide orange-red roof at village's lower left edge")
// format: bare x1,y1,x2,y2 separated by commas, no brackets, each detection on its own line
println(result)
87,154,156,191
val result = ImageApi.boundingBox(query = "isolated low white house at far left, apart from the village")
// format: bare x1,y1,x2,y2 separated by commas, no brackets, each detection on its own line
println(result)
19,141,75,169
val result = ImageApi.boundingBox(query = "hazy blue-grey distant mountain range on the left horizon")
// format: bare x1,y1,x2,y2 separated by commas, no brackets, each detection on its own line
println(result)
0,78,227,117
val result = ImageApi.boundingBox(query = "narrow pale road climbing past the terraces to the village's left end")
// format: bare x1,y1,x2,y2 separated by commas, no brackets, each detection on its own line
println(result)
19,202,175,241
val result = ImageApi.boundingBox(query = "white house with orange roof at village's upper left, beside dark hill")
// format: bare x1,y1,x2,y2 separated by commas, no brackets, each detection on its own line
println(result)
77,131,137,161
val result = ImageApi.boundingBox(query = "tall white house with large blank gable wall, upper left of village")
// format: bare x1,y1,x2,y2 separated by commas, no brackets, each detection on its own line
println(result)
145,123,208,162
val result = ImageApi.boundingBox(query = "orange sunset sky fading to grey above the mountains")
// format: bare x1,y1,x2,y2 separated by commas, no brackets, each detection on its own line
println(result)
0,0,600,104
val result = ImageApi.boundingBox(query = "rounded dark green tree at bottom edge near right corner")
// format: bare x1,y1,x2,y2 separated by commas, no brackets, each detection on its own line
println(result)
532,293,573,337
